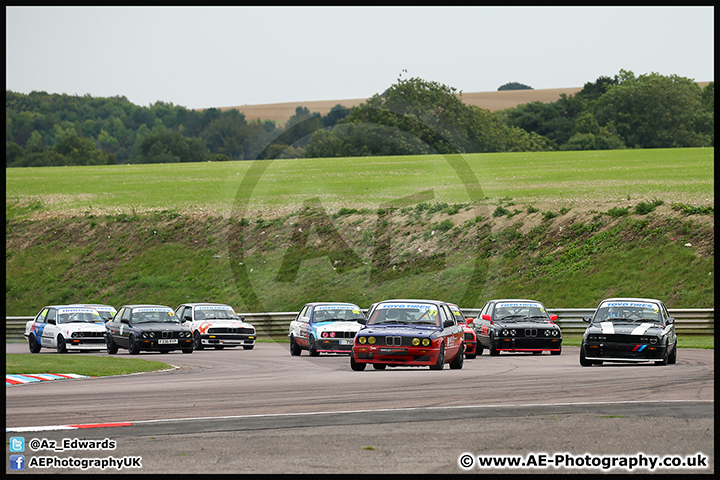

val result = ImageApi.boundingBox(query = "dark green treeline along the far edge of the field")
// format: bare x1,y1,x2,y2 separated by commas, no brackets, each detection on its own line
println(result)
5,70,715,167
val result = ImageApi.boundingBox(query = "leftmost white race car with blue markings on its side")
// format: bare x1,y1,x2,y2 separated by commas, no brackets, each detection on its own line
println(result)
24,305,105,353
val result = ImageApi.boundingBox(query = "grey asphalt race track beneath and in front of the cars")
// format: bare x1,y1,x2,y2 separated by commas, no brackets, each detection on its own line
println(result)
5,343,715,474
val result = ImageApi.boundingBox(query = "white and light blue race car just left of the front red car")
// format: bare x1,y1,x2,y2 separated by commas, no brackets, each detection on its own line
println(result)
288,302,365,356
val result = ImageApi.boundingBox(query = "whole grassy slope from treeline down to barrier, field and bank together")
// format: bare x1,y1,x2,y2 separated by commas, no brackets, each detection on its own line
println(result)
6,149,714,315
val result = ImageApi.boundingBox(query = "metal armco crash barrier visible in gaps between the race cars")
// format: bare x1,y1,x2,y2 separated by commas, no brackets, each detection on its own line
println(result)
5,308,715,341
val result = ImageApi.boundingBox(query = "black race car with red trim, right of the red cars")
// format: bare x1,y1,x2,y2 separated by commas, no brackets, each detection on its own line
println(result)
473,299,562,356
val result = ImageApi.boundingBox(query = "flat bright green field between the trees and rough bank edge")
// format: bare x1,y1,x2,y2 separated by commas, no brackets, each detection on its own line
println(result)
5,148,714,218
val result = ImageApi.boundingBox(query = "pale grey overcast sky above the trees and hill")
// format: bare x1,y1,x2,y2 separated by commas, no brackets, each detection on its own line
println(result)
5,6,715,108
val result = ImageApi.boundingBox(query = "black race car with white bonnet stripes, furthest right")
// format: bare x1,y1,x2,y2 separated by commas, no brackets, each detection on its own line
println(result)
580,298,677,367
